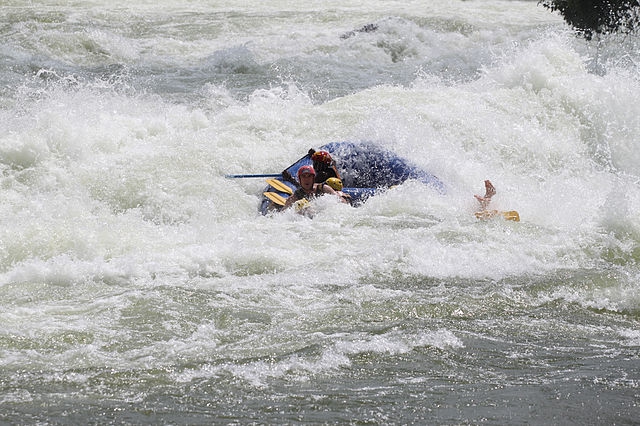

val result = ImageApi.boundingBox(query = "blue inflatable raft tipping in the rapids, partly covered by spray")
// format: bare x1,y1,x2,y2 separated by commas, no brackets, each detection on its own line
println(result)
260,142,445,214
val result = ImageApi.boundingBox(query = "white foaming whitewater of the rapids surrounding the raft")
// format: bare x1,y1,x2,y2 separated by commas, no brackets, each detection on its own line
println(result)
0,1,640,394
